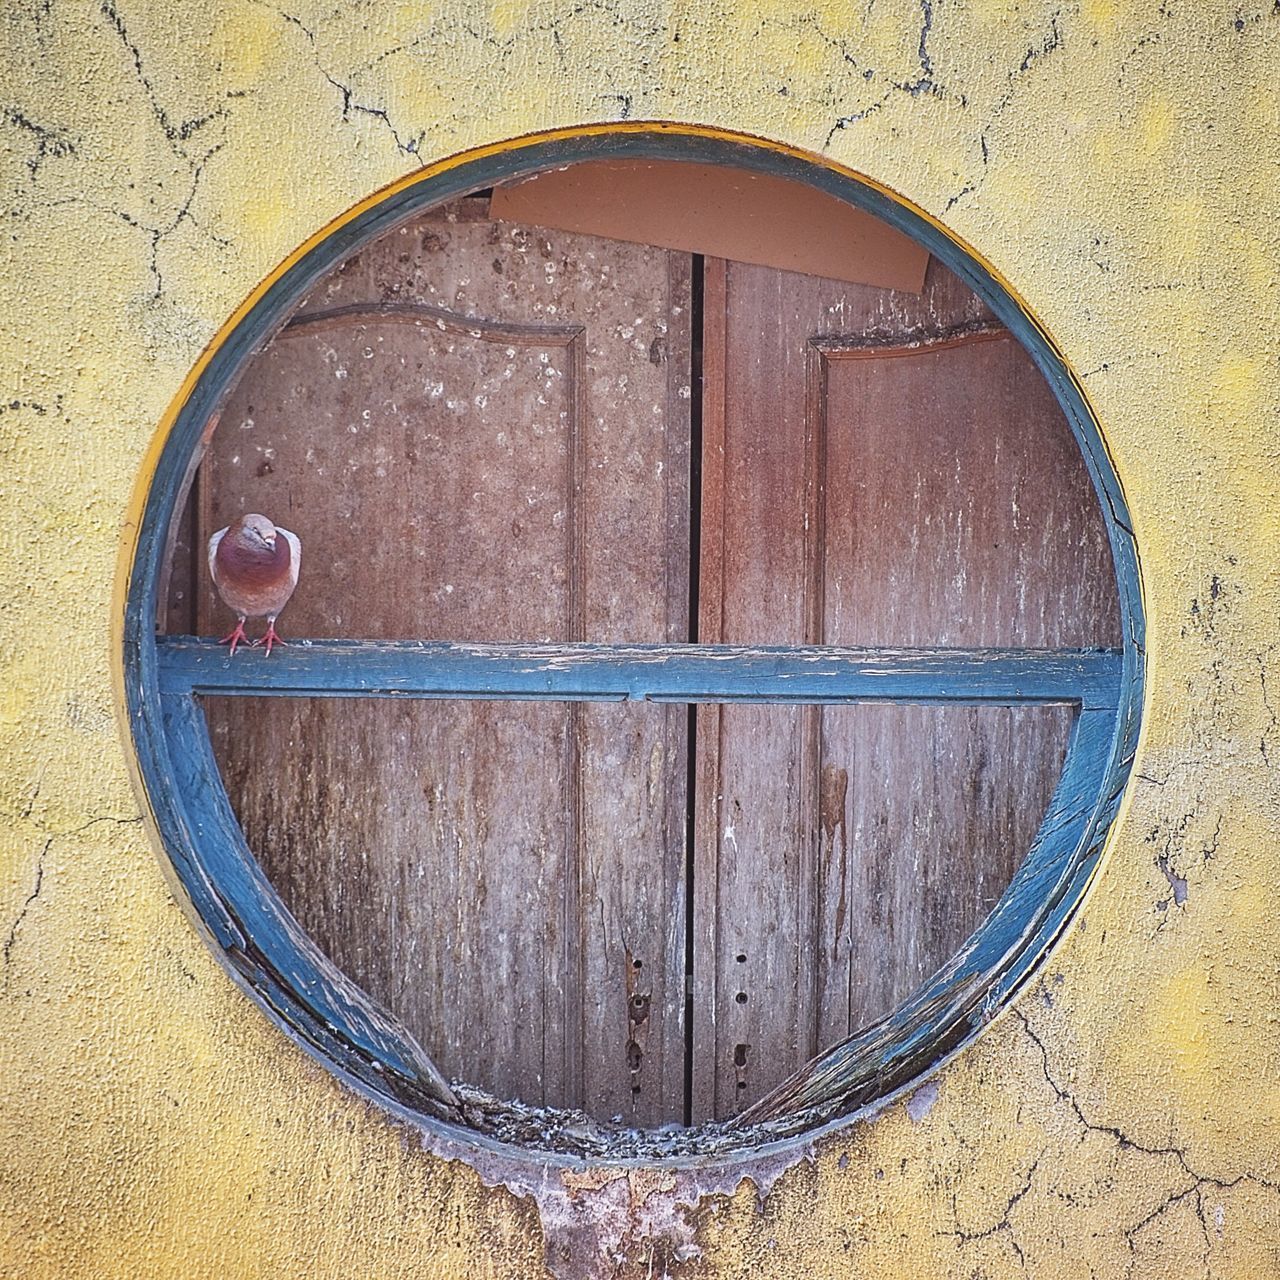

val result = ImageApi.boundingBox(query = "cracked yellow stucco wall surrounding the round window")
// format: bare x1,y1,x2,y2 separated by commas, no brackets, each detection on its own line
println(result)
0,0,1280,1280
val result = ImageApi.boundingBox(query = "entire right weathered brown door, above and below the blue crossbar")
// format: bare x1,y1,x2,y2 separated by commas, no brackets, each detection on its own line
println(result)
694,254,1119,1117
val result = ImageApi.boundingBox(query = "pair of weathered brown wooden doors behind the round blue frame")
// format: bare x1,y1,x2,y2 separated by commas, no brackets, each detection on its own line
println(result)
170,201,1117,1125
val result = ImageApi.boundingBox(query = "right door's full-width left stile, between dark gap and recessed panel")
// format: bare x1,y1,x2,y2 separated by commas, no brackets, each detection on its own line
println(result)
692,254,824,1121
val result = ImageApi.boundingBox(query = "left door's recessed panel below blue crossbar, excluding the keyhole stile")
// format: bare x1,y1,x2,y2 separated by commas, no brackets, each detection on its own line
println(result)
206,698,581,1103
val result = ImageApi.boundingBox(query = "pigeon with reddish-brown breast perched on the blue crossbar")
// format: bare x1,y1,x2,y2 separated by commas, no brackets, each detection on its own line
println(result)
209,515,302,657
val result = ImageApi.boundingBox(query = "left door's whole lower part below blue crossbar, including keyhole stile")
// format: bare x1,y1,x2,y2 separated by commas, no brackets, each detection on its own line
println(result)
205,698,685,1124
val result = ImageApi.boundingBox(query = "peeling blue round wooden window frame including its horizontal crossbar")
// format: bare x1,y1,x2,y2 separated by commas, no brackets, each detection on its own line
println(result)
124,127,1144,1155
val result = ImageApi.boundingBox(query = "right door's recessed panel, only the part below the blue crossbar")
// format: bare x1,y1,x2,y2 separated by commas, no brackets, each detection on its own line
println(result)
801,707,1071,1055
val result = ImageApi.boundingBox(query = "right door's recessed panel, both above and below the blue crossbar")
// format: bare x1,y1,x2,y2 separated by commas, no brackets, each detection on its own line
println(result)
812,326,1119,1043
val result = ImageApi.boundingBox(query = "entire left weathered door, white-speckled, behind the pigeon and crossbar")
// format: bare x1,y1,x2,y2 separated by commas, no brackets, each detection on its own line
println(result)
189,201,690,1124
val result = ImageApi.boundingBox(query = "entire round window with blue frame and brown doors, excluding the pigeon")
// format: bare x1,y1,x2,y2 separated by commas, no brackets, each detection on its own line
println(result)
127,132,1140,1157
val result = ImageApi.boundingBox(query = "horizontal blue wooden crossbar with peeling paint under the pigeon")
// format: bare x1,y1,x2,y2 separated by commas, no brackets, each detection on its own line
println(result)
156,636,1121,710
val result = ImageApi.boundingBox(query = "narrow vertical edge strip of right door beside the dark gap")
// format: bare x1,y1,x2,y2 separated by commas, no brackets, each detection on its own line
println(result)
686,257,728,1124
